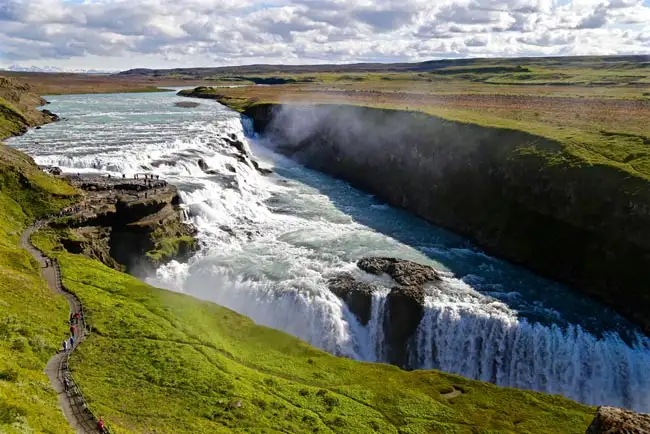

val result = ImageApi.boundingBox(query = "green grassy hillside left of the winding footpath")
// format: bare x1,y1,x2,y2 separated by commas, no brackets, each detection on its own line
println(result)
0,145,75,433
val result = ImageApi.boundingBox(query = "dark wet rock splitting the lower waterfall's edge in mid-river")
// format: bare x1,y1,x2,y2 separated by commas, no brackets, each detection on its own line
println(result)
328,257,442,368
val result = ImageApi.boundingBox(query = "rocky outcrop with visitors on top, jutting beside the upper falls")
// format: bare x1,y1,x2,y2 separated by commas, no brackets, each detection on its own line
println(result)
48,172,198,277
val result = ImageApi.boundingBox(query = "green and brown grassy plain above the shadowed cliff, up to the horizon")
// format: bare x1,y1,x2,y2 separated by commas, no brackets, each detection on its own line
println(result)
177,57,650,179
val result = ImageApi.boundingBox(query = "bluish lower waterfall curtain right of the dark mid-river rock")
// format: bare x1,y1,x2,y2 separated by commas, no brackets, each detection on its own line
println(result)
410,284,650,411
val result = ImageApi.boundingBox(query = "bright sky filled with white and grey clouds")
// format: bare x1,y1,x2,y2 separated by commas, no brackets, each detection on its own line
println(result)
0,0,650,70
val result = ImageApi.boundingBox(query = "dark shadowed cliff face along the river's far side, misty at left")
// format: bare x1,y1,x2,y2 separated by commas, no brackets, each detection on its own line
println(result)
245,105,650,334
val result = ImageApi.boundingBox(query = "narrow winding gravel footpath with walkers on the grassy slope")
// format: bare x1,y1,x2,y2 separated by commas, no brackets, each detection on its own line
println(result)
20,221,100,433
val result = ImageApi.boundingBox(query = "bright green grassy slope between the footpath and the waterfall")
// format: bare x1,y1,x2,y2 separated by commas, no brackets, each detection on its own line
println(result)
35,231,593,433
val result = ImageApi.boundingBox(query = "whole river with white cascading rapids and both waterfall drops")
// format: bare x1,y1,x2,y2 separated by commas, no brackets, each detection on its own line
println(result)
9,92,650,411
